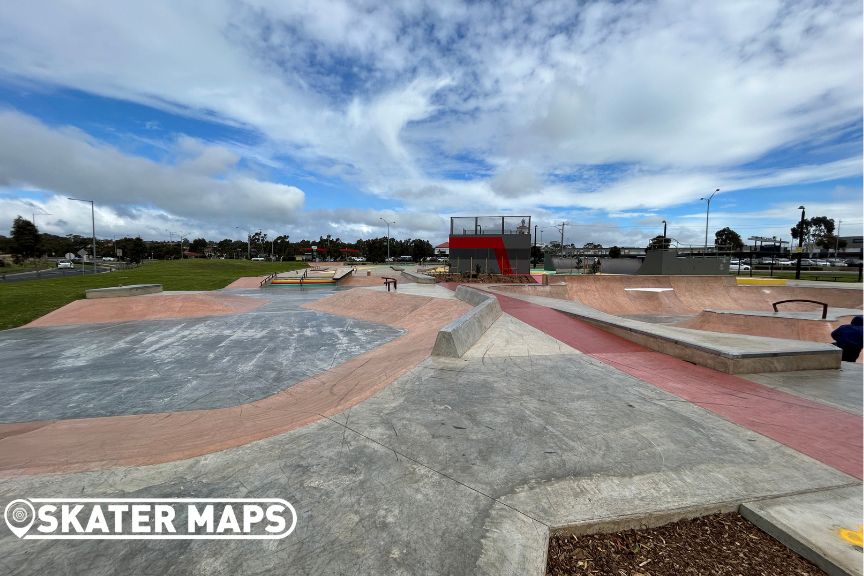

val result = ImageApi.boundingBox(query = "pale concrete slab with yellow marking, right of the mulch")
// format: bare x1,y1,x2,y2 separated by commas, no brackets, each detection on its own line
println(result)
740,485,864,576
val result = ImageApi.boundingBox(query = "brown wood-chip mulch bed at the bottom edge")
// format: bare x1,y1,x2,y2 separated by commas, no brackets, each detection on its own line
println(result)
546,513,825,576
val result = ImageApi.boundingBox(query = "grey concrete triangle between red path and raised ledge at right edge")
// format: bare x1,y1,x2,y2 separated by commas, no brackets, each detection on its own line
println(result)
741,362,864,414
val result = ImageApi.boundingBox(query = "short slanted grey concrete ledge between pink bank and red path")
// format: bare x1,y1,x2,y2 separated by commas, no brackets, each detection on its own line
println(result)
432,286,501,358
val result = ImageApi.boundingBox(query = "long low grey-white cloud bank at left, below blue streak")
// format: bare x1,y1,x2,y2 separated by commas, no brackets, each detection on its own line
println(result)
0,111,304,222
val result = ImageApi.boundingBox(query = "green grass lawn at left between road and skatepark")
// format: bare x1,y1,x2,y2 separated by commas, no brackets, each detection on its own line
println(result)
0,260,306,329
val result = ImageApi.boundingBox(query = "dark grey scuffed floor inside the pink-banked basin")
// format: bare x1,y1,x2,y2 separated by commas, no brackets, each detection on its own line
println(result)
0,291,402,422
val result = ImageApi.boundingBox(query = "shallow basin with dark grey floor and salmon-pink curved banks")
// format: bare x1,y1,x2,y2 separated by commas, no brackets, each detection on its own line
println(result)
0,288,470,478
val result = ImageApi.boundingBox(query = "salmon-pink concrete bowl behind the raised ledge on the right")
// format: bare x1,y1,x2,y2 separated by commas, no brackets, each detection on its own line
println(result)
495,275,862,342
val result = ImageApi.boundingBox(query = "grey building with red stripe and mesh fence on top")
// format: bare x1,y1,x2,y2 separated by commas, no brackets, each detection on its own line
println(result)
447,216,531,274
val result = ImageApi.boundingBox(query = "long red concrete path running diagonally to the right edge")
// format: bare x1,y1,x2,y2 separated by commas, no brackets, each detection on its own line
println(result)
496,287,864,479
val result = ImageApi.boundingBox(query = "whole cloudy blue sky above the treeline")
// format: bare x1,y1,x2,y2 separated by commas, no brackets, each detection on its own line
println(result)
0,0,864,246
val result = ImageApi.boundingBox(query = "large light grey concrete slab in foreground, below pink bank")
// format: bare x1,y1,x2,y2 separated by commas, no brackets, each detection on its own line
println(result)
0,355,854,576
